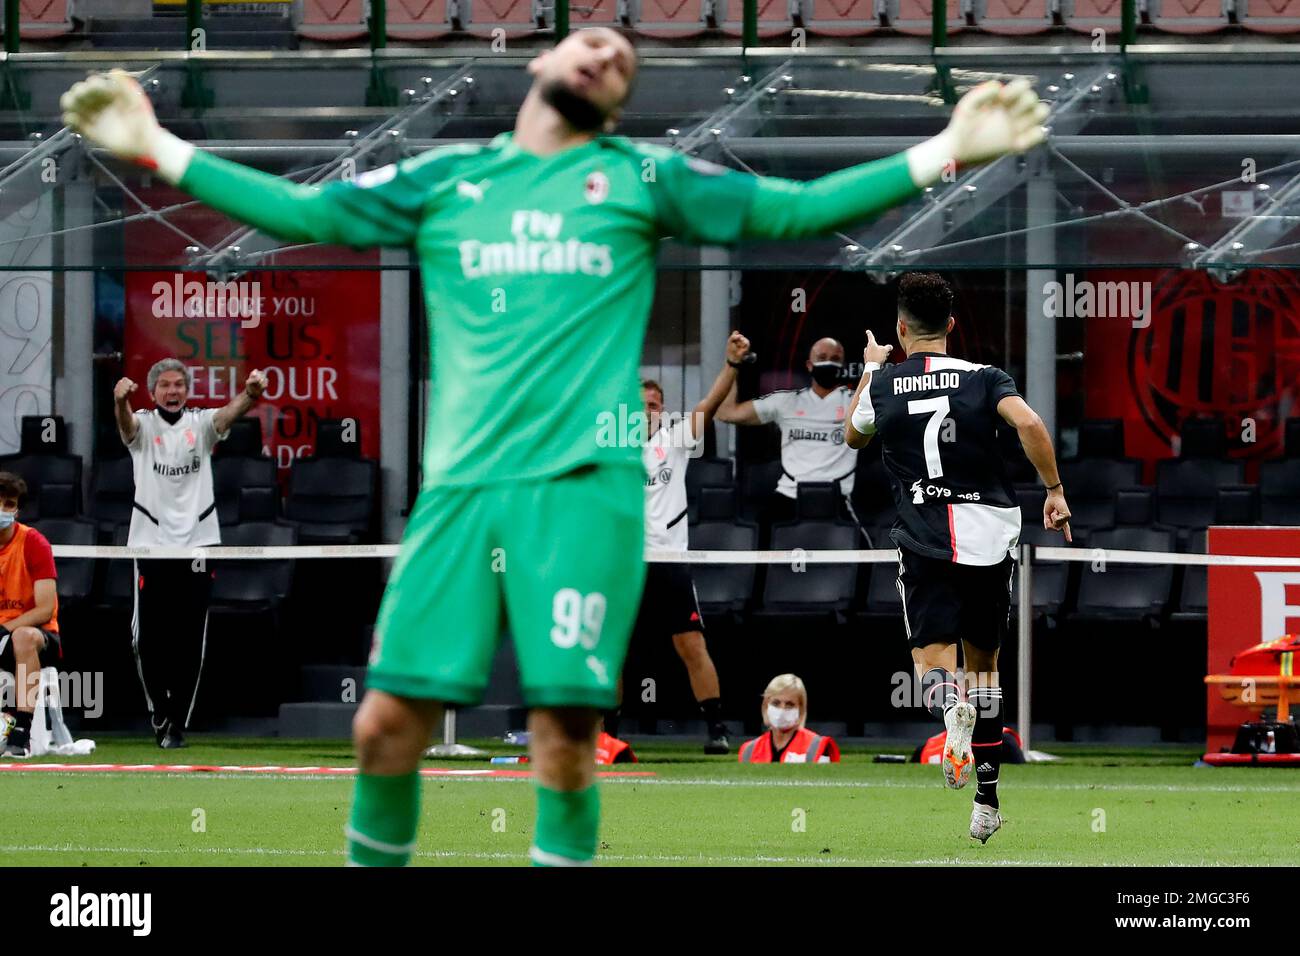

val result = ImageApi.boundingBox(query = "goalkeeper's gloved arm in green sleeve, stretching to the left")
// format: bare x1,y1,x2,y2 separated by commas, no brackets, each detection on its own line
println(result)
60,70,420,247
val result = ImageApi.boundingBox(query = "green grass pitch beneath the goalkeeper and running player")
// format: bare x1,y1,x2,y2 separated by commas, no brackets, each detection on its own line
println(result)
0,735,1300,866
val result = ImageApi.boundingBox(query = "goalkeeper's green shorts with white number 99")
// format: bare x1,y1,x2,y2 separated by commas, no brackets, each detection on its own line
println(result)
367,466,645,709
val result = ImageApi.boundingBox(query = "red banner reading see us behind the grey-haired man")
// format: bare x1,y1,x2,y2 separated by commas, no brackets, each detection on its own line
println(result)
124,187,380,475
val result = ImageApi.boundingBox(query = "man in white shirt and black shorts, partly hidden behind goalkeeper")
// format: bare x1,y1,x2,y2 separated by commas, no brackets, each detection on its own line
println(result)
605,332,749,754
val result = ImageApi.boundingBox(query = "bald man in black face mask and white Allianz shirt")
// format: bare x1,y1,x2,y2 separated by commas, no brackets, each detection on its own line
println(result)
718,338,858,522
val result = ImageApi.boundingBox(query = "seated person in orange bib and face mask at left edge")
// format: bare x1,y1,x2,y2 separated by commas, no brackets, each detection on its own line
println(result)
0,471,64,757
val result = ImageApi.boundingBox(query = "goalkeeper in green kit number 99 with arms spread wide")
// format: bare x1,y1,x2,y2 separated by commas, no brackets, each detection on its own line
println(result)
62,27,1047,866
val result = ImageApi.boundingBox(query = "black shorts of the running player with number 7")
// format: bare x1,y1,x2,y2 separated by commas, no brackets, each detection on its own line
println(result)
897,548,1015,650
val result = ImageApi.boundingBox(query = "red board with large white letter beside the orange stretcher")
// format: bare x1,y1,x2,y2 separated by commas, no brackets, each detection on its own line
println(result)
1205,527,1300,753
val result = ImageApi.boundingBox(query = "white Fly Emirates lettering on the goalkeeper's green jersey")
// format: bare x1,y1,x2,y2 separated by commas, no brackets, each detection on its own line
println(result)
458,209,614,278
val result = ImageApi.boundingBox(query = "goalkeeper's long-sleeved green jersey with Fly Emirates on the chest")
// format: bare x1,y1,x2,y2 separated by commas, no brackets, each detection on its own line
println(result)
179,133,915,488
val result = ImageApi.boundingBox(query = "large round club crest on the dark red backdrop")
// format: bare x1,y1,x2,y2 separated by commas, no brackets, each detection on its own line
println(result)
1128,269,1300,457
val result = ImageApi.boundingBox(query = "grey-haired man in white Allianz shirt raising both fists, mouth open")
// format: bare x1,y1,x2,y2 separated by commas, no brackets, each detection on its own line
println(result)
113,359,267,749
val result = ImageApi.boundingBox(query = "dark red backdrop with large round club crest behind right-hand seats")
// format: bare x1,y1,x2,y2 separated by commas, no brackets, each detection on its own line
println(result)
1081,269,1300,481
